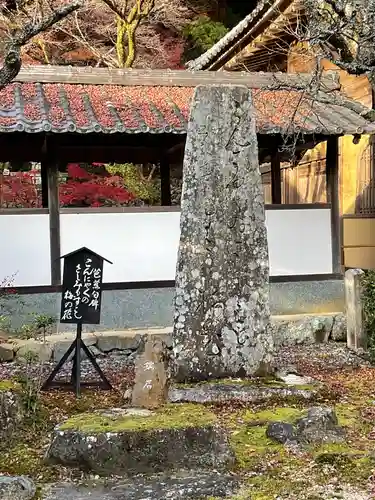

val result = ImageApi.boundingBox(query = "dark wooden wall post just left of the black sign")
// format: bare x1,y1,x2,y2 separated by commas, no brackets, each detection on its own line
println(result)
41,161,61,285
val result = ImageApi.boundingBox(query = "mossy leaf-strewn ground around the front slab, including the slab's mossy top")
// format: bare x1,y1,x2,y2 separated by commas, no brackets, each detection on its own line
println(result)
0,368,375,500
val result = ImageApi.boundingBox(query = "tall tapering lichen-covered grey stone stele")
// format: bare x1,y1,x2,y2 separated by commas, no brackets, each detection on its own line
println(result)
173,85,273,381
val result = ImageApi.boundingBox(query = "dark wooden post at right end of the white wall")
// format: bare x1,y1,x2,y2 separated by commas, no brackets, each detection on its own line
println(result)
326,136,342,274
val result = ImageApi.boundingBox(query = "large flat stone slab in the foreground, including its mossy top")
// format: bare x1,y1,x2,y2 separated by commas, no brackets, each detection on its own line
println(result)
47,405,235,476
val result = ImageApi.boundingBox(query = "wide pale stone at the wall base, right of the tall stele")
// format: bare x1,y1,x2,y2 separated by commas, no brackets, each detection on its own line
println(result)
272,315,334,347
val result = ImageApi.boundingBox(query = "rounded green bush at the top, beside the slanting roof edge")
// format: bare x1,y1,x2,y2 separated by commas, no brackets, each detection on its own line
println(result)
183,16,228,60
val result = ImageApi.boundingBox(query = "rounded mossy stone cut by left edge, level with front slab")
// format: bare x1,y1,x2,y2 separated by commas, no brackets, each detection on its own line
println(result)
0,381,24,446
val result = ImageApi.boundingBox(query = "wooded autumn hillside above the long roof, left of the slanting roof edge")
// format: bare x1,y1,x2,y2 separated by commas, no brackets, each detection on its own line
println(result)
0,0,256,69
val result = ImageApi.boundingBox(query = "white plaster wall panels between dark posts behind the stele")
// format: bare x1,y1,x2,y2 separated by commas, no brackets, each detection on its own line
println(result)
0,209,332,286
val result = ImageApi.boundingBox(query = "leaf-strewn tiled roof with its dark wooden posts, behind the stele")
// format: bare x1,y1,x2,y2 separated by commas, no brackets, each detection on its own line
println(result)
0,66,375,286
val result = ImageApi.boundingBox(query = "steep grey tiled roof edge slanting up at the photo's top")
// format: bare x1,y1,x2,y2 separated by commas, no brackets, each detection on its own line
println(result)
186,0,291,71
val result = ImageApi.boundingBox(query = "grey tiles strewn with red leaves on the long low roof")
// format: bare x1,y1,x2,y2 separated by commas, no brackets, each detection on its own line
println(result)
0,68,375,135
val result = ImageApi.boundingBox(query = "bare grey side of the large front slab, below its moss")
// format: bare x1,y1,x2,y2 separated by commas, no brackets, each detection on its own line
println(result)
47,416,235,476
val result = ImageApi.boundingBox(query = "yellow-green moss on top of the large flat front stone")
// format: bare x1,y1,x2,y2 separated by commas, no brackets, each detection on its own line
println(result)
59,404,217,433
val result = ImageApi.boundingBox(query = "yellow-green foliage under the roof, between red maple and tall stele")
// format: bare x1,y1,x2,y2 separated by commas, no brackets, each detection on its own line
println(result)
106,163,160,205
